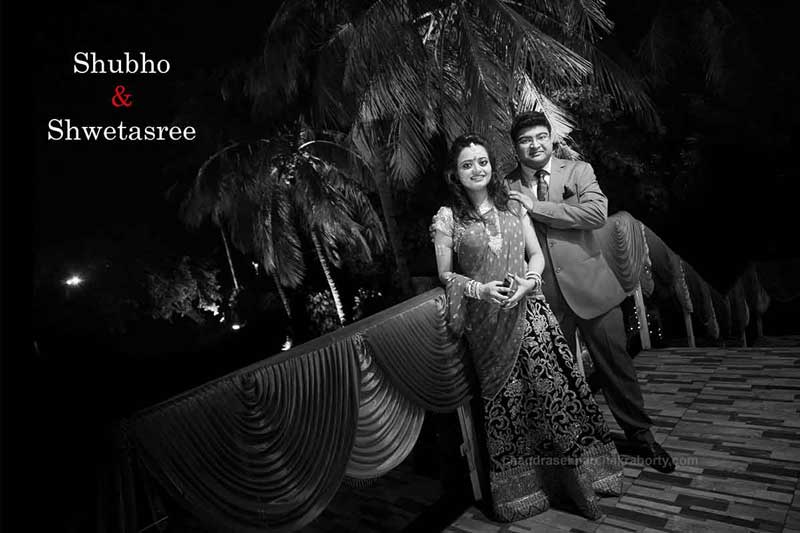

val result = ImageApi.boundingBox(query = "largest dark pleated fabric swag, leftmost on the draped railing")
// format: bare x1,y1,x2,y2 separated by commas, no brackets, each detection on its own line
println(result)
131,339,359,532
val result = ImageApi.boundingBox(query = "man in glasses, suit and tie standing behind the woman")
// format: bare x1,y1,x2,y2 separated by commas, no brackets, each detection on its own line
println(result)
506,112,675,473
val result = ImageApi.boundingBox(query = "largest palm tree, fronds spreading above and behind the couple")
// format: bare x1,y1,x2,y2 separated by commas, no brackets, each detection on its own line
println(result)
245,0,657,292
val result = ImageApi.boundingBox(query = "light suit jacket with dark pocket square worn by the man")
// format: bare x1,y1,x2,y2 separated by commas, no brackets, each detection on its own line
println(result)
506,157,625,319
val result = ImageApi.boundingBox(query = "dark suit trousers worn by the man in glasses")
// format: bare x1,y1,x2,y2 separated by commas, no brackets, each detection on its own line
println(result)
546,276,653,442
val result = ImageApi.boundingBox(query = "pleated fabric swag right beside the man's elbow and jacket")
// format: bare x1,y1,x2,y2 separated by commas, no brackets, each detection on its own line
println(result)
595,211,646,294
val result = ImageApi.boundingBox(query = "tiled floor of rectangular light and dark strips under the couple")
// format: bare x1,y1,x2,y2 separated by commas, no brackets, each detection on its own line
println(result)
446,343,800,533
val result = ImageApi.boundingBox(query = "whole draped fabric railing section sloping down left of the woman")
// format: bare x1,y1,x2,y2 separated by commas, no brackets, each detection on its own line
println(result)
102,289,470,532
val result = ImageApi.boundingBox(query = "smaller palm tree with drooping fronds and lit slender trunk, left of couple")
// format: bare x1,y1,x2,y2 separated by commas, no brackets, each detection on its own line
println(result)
182,127,385,334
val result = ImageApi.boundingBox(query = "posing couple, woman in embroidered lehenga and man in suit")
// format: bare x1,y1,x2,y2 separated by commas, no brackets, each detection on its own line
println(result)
431,112,674,521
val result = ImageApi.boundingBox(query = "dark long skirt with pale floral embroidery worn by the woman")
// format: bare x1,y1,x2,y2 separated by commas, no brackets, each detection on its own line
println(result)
484,298,623,522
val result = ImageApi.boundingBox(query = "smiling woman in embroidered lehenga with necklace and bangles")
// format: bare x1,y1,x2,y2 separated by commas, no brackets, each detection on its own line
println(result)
431,134,622,521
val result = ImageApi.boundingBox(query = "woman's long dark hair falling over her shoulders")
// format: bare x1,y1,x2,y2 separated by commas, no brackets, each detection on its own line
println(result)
444,133,508,220
